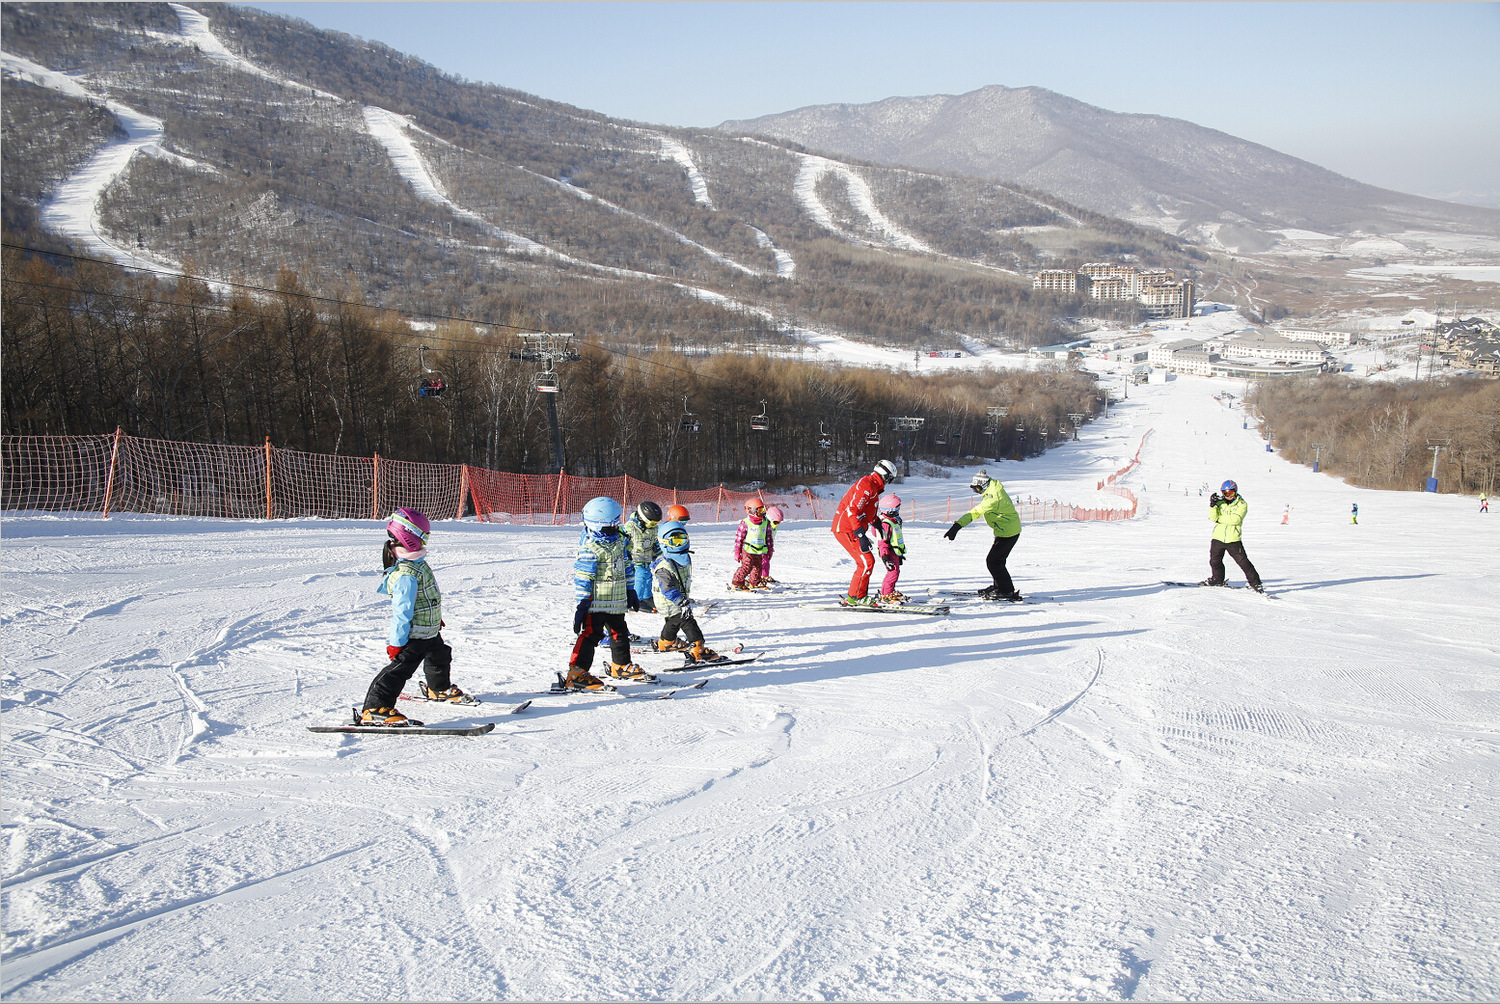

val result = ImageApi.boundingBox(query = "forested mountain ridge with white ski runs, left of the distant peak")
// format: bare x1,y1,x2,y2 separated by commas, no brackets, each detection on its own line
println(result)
3,3,1193,347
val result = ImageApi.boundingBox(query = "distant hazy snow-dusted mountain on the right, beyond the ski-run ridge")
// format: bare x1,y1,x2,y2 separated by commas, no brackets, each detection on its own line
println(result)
720,87,1500,251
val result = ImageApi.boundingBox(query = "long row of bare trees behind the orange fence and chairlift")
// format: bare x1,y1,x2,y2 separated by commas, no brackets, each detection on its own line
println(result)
3,251,1097,488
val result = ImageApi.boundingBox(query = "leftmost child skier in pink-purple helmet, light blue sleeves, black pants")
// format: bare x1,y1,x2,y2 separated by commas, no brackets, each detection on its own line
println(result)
360,509,474,728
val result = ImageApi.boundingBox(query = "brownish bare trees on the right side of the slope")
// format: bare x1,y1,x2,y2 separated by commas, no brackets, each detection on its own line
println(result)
1248,375,1500,494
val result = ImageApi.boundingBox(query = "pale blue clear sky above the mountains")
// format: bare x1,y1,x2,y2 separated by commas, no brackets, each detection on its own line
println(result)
251,3,1500,206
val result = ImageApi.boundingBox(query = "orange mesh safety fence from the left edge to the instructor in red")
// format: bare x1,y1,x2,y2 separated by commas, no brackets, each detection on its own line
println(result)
0,429,822,525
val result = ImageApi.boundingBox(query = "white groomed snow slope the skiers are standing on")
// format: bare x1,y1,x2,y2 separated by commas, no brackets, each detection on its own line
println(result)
0,378,1500,999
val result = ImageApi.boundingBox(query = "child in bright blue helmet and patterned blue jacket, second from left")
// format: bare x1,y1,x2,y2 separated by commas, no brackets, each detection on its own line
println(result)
563,497,656,690
